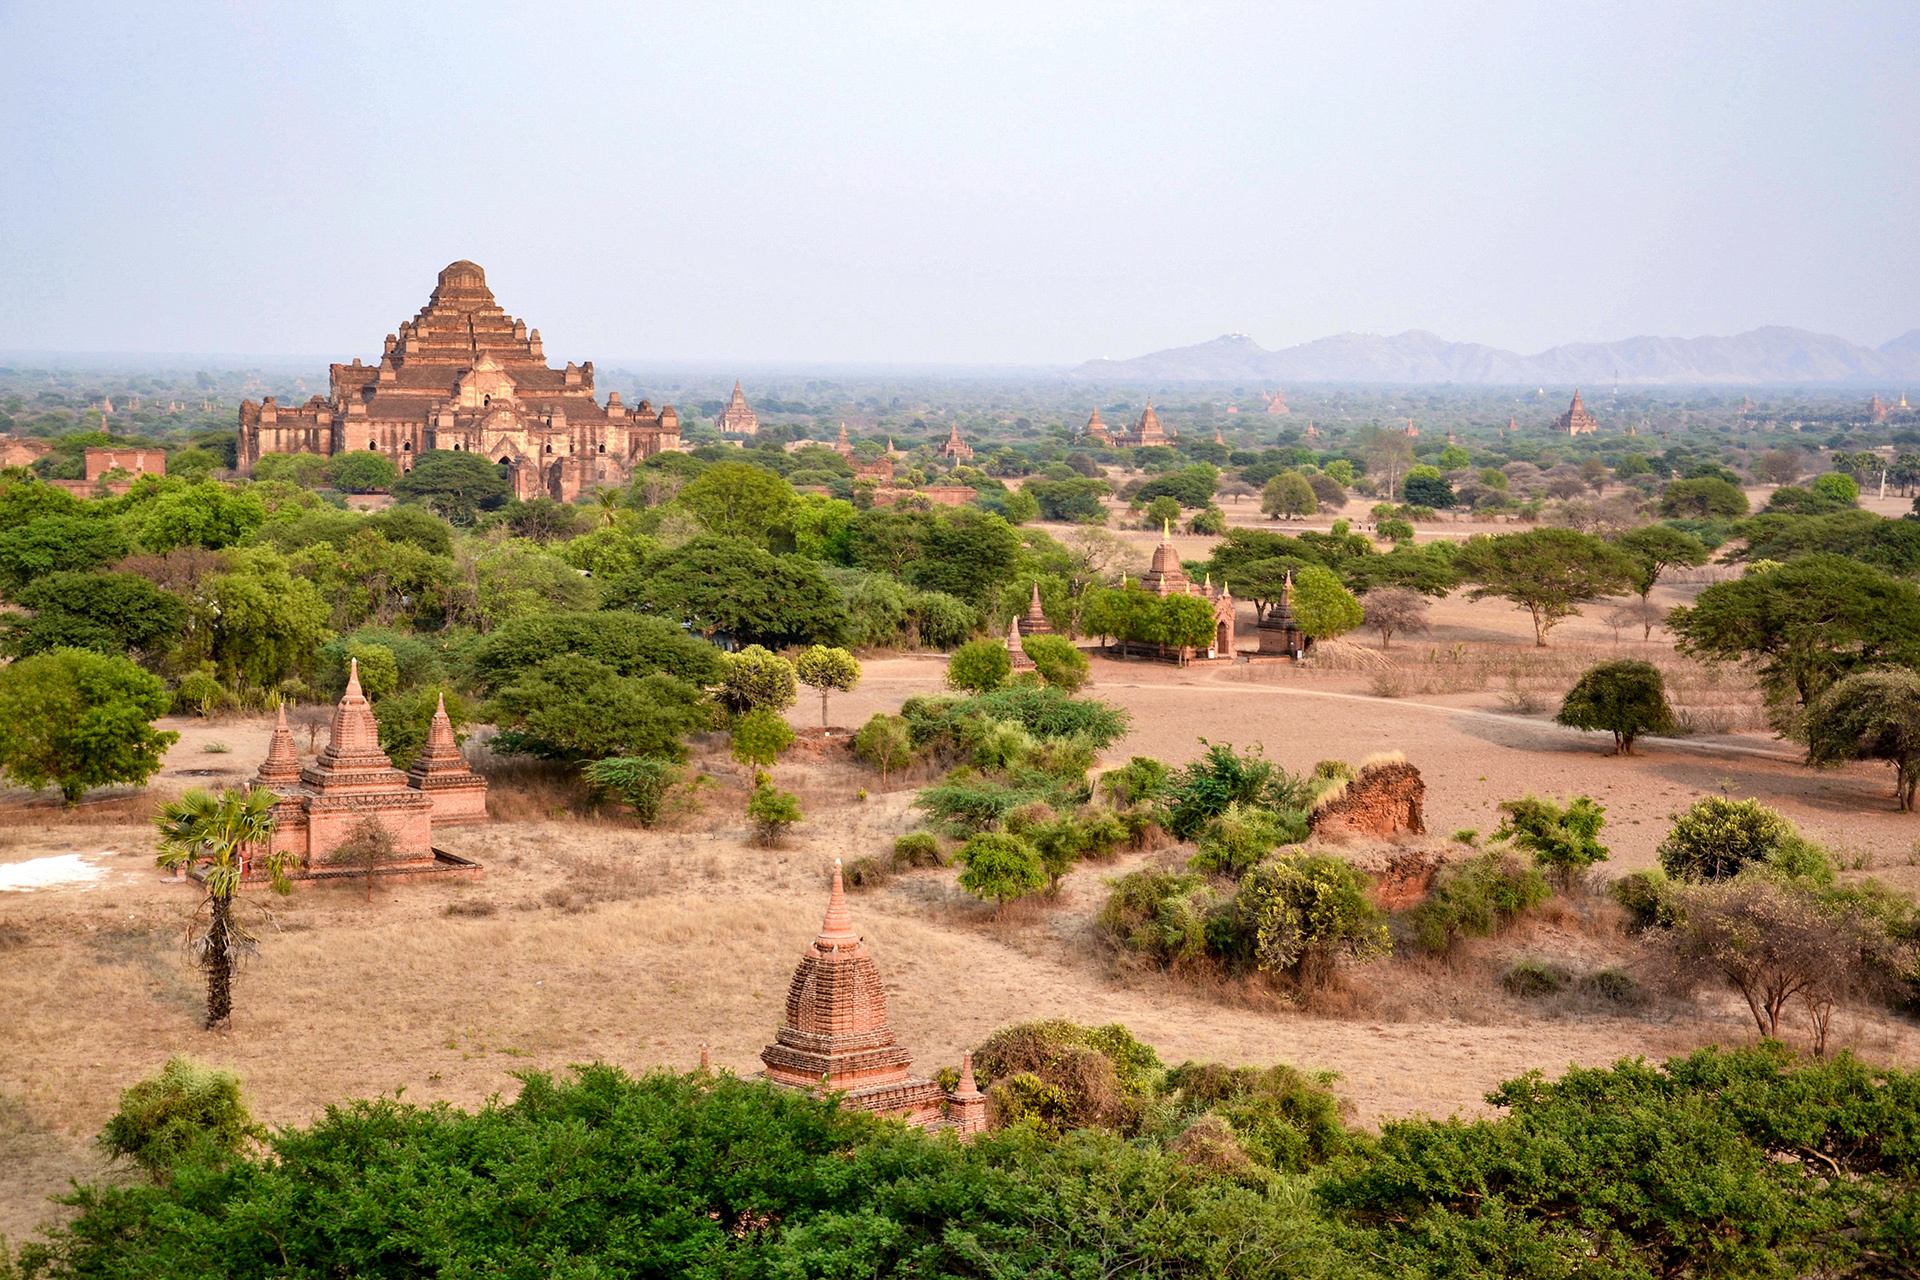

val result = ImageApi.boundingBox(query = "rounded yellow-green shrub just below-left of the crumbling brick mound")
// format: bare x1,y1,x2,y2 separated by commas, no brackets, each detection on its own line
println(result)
1235,854,1390,984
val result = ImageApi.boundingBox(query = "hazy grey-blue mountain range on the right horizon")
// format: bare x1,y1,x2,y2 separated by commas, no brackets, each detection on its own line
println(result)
1069,324,1920,388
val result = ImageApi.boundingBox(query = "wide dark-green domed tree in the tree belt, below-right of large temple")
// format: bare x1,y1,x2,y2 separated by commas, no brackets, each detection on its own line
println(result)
607,537,847,647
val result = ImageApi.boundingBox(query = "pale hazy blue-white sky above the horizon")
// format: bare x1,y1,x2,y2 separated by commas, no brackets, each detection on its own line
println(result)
0,0,1920,365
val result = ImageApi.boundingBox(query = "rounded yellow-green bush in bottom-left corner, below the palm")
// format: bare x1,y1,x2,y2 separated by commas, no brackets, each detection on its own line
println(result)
98,1054,267,1184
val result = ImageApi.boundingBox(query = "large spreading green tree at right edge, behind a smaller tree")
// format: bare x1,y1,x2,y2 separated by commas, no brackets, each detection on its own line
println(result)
1667,555,1920,735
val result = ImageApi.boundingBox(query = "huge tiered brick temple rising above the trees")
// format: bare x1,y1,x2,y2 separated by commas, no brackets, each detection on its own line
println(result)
240,259,680,501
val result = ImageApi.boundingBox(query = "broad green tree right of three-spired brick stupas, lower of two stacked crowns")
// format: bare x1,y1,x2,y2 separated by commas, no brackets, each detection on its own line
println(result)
480,654,708,762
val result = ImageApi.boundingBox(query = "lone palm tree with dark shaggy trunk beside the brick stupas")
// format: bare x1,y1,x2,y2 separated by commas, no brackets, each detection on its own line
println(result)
154,787,294,1031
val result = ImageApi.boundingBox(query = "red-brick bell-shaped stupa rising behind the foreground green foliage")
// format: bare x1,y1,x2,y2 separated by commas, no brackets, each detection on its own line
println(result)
760,860,947,1125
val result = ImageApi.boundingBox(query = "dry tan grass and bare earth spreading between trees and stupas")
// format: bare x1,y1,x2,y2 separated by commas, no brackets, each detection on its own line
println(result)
0,583,1920,1236
